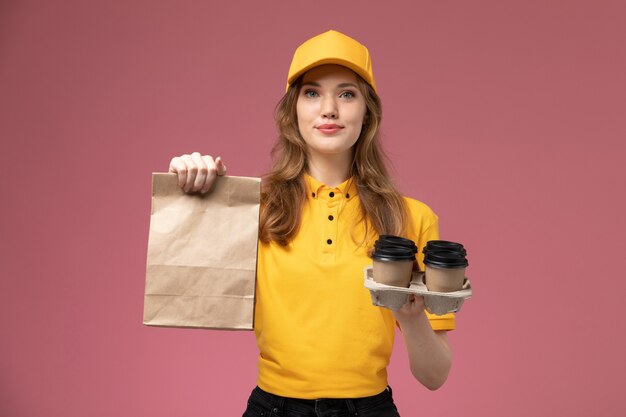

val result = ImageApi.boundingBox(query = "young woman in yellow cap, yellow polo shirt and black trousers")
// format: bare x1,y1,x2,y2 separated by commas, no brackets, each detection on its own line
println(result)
170,31,454,417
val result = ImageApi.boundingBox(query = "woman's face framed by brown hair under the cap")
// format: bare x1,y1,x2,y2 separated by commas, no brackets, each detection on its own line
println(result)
296,65,367,162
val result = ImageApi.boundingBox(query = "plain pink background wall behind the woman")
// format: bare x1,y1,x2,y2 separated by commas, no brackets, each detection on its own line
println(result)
0,0,626,417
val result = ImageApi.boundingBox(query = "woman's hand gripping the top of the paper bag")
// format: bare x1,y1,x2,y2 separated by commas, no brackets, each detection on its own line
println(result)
169,152,226,193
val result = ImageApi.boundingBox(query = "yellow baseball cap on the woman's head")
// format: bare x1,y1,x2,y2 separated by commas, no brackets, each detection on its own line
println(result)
287,30,376,91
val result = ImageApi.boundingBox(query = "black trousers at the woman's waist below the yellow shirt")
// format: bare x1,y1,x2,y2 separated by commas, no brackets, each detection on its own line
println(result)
243,387,400,417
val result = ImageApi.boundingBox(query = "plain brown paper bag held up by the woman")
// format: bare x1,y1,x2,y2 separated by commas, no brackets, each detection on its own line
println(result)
143,174,261,330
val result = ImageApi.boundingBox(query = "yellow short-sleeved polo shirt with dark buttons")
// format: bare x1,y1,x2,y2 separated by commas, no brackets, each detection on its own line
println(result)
254,176,454,399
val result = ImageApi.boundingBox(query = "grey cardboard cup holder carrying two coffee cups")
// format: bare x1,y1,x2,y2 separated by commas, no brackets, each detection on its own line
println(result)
364,266,472,315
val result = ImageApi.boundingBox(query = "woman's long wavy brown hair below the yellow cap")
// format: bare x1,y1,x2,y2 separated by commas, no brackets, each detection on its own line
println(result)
260,75,408,245
